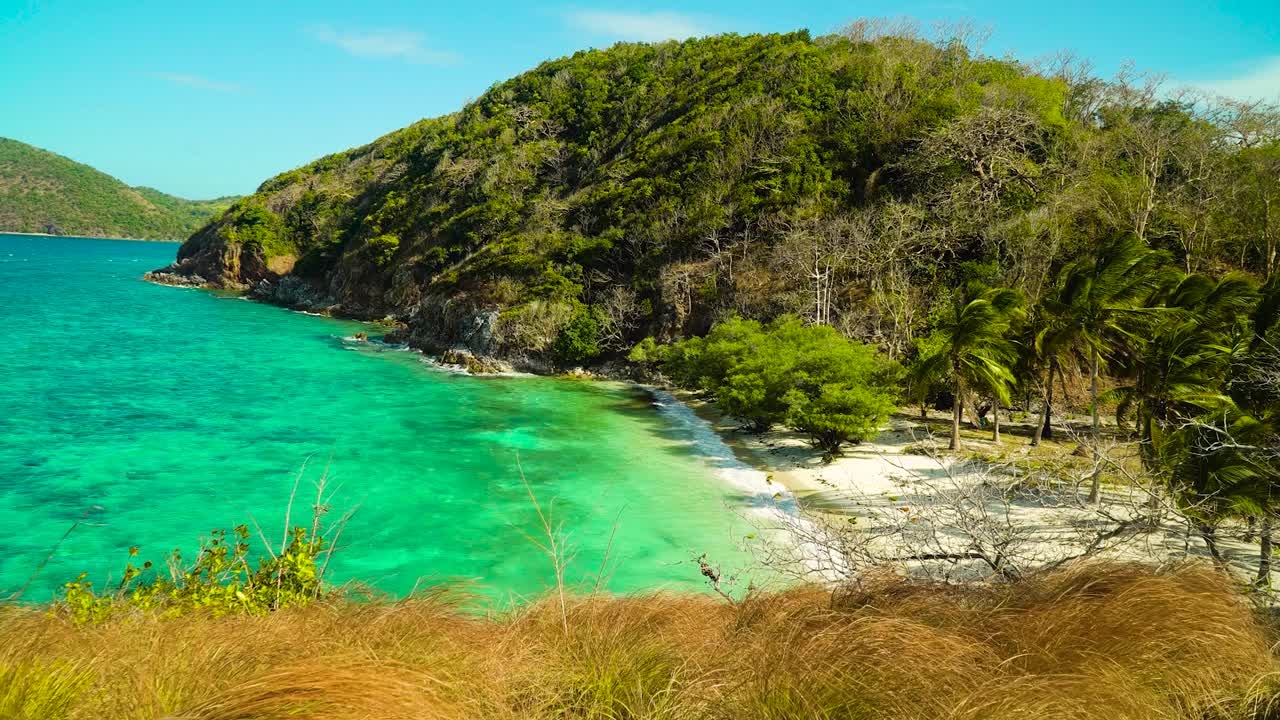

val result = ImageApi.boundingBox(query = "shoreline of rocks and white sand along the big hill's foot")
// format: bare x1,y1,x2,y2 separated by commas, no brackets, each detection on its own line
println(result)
135,277,1274,584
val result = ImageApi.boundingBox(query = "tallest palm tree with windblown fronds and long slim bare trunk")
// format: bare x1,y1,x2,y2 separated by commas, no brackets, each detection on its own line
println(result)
1037,237,1167,502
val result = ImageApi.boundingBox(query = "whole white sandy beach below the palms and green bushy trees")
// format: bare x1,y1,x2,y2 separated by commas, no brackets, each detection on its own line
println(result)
676,392,1276,580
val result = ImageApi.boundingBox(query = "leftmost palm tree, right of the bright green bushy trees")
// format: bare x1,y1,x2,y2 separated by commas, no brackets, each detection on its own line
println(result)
916,283,1023,450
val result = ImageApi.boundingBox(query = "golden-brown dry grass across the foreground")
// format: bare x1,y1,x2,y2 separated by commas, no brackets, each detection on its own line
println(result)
0,565,1277,720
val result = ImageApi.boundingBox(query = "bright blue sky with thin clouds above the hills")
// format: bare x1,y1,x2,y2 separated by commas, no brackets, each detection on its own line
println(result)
0,0,1280,197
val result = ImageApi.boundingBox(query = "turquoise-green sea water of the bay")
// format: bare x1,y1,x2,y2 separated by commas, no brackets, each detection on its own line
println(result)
0,234,772,600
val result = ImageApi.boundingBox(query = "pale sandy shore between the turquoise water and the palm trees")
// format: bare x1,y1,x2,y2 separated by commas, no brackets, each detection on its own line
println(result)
686,391,1280,583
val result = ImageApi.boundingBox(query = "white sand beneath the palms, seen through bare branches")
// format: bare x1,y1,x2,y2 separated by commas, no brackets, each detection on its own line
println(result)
678,393,1274,579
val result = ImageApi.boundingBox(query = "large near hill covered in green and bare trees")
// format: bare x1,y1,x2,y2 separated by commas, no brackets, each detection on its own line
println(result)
152,26,1280,364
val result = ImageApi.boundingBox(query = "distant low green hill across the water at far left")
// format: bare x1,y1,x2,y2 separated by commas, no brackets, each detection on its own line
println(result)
0,137,236,240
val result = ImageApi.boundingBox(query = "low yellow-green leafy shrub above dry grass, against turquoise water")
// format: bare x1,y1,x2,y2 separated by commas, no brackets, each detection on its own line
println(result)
54,525,329,623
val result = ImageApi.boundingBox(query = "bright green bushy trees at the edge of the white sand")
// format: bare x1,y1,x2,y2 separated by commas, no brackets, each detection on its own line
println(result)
650,316,900,454
